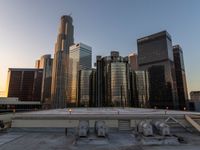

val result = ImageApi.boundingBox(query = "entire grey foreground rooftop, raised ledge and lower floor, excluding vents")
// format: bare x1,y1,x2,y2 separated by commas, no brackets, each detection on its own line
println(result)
0,108,200,150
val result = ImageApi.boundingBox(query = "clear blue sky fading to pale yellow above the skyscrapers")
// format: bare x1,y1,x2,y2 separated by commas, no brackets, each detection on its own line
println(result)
0,0,200,94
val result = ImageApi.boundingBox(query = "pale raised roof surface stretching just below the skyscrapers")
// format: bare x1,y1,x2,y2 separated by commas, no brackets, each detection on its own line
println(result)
12,107,200,115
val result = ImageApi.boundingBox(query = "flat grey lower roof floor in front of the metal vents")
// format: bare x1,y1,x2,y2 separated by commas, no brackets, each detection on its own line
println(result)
0,131,200,150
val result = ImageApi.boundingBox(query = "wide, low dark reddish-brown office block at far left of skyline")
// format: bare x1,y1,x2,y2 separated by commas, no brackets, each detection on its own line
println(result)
6,68,43,101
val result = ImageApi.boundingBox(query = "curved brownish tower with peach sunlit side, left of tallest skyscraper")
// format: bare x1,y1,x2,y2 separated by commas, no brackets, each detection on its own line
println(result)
35,54,53,108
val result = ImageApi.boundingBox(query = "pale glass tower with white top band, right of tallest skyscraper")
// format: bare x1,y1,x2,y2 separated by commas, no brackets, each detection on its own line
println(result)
67,43,92,106
